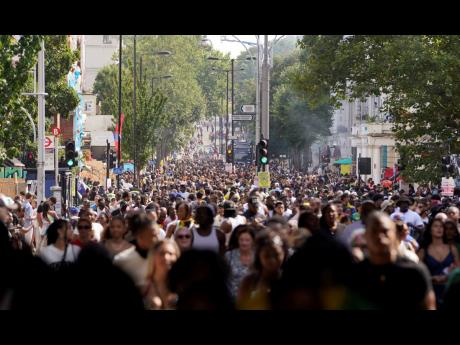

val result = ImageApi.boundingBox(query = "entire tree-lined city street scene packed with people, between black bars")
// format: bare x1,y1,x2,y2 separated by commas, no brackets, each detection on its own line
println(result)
0,35,460,311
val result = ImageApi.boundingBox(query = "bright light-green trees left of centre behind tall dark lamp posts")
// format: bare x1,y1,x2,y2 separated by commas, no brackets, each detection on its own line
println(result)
94,35,225,166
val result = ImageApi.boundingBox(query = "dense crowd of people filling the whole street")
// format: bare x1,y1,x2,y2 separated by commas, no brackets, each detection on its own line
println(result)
0,126,460,310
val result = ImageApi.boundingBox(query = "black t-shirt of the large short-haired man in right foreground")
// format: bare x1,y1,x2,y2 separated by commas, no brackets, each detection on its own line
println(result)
352,258,433,310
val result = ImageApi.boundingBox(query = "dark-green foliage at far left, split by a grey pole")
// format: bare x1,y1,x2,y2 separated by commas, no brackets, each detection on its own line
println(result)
0,35,78,161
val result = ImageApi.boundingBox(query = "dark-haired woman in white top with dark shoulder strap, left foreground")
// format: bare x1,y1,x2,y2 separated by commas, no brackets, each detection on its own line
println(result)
40,219,80,269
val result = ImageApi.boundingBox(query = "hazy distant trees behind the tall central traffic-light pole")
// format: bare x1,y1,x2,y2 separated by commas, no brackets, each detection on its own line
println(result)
230,36,333,168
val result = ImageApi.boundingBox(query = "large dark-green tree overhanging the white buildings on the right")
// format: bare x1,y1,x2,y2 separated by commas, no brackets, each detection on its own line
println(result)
296,35,460,183
